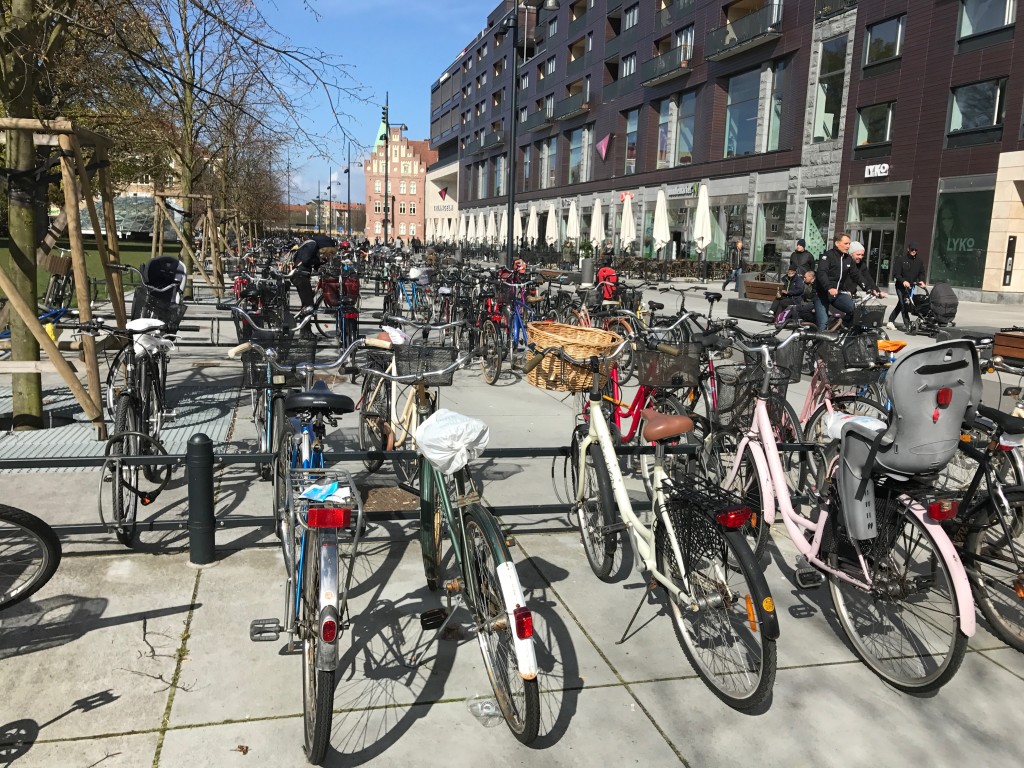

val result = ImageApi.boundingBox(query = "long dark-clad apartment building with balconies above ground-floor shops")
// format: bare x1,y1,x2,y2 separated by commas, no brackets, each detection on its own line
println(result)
428,0,1024,293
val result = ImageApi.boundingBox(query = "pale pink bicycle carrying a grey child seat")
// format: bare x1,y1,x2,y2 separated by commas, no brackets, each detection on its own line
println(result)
708,331,980,693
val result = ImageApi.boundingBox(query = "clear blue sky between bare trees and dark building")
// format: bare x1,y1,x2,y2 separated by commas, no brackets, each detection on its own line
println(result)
263,0,489,204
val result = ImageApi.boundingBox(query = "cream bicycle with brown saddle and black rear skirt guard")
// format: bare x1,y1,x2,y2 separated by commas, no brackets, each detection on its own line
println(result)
523,339,778,710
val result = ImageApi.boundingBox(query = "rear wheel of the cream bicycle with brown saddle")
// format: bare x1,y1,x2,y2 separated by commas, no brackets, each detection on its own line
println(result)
655,520,777,710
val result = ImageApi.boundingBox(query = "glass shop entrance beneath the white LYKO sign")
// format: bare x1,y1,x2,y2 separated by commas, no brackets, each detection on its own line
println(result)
843,181,910,288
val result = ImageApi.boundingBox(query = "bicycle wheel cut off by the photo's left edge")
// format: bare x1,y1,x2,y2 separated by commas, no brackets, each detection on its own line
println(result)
0,504,60,610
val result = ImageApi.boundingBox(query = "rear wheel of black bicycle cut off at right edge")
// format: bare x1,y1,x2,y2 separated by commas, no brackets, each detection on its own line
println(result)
964,492,1024,652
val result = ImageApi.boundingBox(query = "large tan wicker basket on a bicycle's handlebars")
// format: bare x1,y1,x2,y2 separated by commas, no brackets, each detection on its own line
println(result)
526,322,622,392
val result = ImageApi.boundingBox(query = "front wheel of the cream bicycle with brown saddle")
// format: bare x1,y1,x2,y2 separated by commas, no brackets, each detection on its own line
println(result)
569,442,617,582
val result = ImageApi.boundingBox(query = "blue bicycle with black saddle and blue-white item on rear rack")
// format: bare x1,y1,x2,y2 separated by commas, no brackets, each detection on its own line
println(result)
235,341,366,765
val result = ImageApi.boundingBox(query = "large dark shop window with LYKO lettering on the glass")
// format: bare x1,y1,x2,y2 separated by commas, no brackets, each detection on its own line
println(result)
929,189,994,288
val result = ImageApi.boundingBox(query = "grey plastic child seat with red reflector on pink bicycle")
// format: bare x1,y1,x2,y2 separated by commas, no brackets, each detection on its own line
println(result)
833,339,981,539
